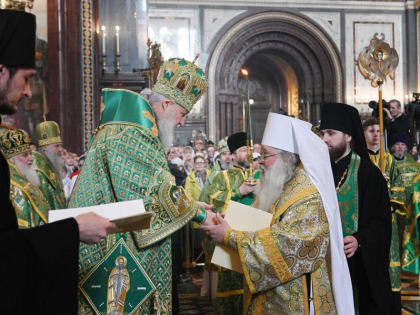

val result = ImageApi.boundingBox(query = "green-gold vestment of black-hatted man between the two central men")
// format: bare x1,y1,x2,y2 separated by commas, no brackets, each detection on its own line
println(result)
203,167,260,314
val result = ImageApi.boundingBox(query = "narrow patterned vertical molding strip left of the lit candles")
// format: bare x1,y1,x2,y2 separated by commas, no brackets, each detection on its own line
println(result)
80,0,95,150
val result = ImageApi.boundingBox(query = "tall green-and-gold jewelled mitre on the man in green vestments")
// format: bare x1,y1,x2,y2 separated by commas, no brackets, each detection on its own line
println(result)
152,58,208,111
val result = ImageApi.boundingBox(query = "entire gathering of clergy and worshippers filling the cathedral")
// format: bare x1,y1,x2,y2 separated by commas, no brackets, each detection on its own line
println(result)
0,10,420,315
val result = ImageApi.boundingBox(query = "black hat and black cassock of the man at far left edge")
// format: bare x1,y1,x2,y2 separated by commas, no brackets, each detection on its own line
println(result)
0,10,79,315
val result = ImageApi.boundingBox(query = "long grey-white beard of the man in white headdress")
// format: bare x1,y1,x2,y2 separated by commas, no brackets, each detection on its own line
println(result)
253,151,299,212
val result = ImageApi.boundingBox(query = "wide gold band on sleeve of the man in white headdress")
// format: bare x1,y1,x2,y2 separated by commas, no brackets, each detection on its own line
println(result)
258,228,293,283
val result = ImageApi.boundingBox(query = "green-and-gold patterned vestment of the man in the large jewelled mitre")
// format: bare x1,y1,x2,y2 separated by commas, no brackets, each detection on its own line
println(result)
69,89,205,314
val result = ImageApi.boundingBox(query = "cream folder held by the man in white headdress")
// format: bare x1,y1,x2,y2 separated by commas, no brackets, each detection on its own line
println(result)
211,200,273,273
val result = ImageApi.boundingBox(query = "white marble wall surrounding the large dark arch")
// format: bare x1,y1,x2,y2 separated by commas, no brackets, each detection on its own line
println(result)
149,0,420,138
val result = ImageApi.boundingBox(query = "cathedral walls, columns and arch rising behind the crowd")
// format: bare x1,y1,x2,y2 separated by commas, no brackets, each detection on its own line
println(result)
0,0,420,314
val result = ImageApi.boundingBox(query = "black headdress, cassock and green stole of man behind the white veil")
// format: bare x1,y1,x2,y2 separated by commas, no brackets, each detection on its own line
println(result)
320,103,392,315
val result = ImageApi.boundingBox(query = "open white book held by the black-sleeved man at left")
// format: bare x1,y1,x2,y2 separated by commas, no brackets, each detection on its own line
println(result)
48,199,154,232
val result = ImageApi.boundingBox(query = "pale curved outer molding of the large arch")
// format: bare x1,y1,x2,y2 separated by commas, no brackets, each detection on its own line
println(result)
207,11,343,139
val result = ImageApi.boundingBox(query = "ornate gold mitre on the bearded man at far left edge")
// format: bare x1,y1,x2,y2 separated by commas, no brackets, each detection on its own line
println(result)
0,129,31,159
